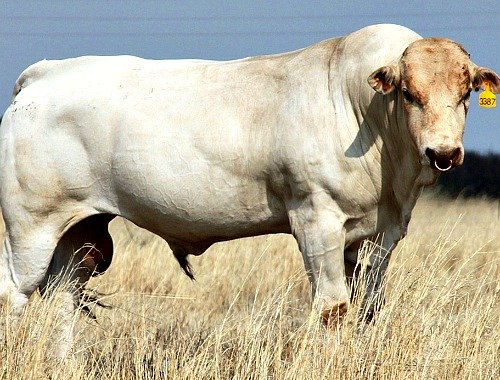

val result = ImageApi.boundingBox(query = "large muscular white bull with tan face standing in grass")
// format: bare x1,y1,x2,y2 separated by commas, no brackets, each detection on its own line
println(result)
0,25,500,354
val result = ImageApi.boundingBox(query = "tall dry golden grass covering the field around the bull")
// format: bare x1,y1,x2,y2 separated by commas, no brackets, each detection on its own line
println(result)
0,199,500,380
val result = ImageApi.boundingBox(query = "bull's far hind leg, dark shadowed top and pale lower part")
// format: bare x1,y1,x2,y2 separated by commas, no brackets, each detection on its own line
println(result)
41,214,114,358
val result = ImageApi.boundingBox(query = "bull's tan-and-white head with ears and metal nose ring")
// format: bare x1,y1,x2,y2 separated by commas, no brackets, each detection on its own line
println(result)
368,38,500,171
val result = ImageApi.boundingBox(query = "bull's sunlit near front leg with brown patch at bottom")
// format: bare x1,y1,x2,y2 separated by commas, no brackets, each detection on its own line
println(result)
287,193,349,326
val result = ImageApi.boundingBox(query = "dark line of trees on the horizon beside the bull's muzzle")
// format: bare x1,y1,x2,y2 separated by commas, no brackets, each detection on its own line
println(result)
434,152,500,199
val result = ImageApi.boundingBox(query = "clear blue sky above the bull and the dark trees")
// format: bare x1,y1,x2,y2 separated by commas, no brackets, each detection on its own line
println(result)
0,0,500,152
